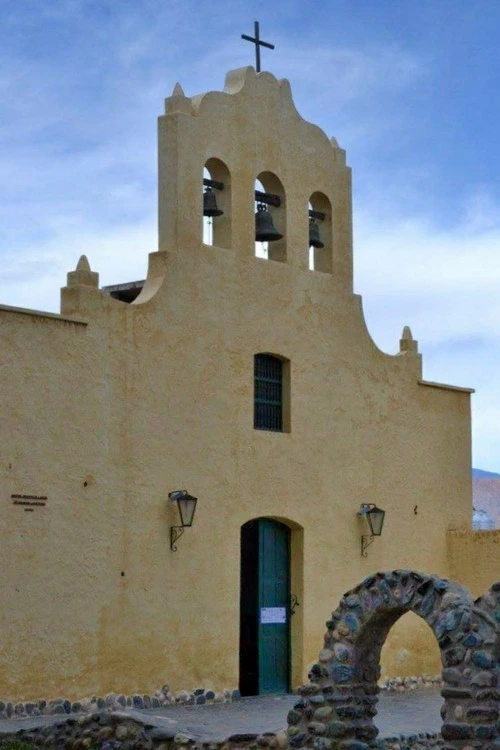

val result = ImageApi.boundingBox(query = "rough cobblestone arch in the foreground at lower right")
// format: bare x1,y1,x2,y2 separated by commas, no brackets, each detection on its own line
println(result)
288,570,500,750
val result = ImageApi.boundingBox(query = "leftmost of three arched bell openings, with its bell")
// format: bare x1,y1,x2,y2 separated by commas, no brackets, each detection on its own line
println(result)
203,158,232,248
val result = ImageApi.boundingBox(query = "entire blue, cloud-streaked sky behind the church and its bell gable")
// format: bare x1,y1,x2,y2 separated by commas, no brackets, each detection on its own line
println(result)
0,0,500,471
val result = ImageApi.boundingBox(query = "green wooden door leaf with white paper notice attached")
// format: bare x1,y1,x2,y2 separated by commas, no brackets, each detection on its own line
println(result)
258,519,290,695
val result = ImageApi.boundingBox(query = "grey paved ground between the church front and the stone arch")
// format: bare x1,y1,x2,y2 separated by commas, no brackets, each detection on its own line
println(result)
0,689,443,742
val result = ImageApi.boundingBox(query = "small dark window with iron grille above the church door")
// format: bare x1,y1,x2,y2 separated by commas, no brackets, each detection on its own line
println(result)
253,354,283,432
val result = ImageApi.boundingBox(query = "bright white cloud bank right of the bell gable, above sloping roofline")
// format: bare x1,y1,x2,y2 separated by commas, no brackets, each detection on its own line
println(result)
354,195,500,470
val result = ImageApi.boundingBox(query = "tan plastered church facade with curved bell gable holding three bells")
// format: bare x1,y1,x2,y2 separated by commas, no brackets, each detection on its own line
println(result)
0,68,471,700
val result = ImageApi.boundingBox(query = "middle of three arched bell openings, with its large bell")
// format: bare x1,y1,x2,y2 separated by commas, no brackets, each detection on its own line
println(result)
254,172,286,263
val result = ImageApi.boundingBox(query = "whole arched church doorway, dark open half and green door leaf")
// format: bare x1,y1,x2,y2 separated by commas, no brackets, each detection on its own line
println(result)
240,518,290,695
